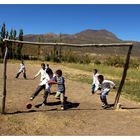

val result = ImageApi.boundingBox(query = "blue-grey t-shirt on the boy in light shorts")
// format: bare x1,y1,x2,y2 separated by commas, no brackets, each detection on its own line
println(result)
53,76,65,93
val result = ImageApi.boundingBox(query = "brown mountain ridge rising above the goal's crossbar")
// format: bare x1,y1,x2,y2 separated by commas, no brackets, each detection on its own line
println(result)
24,29,121,43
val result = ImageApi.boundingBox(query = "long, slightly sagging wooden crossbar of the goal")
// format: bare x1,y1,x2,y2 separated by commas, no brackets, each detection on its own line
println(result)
3,39,133,47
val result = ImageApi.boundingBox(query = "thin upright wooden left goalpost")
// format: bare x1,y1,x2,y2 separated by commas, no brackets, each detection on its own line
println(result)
2,42,8,114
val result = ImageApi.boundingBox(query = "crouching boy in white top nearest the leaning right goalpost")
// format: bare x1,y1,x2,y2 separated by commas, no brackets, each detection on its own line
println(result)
96,75,115,109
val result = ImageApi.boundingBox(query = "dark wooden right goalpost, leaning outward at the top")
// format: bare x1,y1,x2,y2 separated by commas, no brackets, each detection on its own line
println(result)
114,45,133,108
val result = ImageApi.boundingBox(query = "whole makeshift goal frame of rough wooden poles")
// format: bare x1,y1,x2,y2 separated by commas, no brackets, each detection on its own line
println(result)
2,39,133,114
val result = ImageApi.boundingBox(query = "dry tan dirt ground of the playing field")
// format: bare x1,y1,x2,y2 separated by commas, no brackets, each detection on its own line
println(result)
0,63,140,136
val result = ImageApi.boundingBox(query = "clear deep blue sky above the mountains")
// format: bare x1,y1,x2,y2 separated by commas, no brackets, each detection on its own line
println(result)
0,4,140,41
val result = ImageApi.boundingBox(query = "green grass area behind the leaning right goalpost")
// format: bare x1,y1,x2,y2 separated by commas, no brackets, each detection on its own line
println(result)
65,64,140,102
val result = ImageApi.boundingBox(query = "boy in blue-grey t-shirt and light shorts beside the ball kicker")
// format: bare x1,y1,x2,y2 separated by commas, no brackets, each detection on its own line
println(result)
50,69,65,110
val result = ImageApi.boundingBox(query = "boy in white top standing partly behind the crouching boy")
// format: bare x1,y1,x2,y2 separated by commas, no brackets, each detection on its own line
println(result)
91,69,99,94
